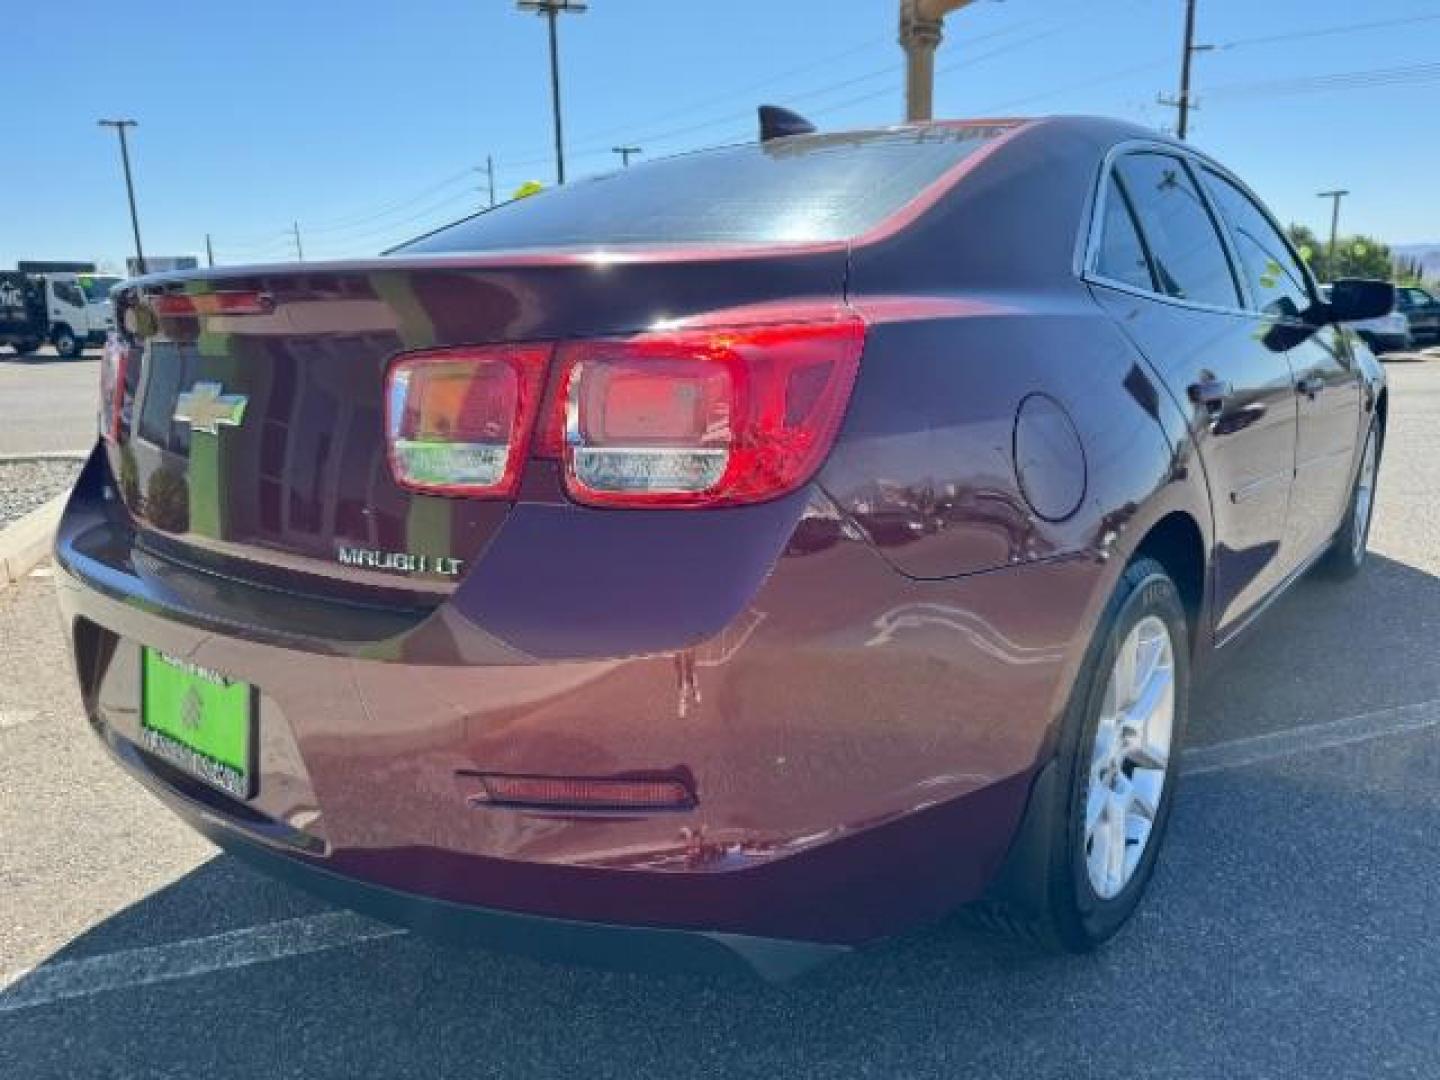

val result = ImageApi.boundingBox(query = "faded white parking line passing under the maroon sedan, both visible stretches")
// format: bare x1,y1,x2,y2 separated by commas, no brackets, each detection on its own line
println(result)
0,698,1440,1014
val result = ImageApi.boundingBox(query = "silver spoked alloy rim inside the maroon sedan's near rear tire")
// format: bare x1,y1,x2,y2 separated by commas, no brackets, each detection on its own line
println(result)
1084,615,1175,900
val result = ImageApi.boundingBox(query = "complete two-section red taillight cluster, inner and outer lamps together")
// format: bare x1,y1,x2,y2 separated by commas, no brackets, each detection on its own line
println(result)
386,317,865,507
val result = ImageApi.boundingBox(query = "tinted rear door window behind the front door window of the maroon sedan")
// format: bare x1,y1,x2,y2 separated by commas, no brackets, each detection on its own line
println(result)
1116,154,1240,308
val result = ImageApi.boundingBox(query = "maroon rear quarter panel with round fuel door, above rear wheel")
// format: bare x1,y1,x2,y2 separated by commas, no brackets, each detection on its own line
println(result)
821,121,1210,593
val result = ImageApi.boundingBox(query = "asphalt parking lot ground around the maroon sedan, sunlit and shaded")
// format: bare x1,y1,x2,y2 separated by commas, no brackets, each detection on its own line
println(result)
0,357,1440,1080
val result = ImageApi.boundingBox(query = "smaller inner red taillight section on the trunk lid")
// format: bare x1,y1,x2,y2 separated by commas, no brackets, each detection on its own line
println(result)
384,346,550,495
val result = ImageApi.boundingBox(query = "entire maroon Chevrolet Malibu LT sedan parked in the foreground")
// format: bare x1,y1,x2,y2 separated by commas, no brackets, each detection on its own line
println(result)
55,118,1392,978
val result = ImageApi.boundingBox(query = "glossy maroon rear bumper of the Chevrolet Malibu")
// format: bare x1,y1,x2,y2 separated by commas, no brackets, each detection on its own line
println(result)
56,443,1096,976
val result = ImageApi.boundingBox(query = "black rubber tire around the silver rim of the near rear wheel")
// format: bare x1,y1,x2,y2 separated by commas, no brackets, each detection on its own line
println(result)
971,557,1189,953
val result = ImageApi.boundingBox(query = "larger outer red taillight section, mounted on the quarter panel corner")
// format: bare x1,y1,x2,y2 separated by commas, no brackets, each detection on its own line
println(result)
547,318,864,507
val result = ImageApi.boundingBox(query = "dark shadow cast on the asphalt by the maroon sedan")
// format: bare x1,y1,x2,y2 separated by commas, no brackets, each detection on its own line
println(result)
8,557,1440,1080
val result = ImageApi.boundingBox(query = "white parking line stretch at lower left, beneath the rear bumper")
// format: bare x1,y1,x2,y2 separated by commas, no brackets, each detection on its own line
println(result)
0,912,405,1014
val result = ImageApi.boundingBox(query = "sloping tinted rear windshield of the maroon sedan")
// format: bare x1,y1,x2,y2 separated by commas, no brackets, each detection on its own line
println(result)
389,127,1008,255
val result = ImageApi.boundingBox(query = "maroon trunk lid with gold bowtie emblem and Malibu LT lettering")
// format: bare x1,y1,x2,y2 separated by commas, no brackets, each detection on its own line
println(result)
107,253,845,602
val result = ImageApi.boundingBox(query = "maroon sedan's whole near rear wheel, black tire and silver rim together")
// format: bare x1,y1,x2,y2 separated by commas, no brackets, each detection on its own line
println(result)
979,557,1189,952
